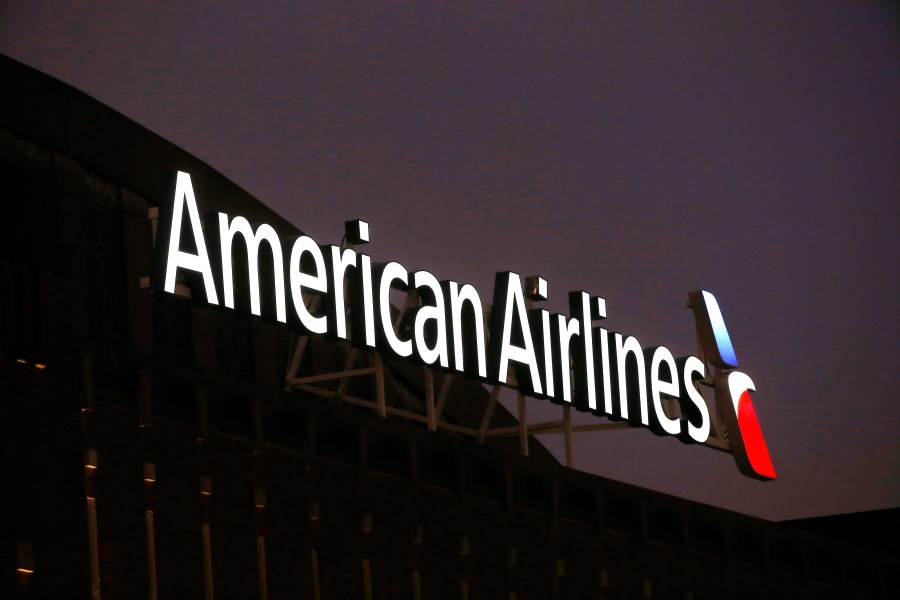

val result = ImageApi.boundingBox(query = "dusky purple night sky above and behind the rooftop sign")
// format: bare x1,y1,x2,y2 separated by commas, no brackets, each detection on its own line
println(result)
0,1,900,520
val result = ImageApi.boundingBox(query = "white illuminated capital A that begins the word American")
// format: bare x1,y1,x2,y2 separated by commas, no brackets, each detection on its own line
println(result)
163,171,219,304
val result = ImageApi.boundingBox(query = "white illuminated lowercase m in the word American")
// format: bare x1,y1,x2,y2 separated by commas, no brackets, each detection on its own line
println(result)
219,213,287,323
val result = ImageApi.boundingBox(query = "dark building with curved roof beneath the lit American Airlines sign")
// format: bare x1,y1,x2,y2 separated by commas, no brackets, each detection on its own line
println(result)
0,57,898,600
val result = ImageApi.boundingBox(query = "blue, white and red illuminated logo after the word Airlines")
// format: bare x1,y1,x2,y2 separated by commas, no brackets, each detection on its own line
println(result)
690,291,775,480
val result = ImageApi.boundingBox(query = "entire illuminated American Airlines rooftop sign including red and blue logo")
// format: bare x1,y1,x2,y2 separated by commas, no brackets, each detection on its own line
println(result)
151,172,775,479
